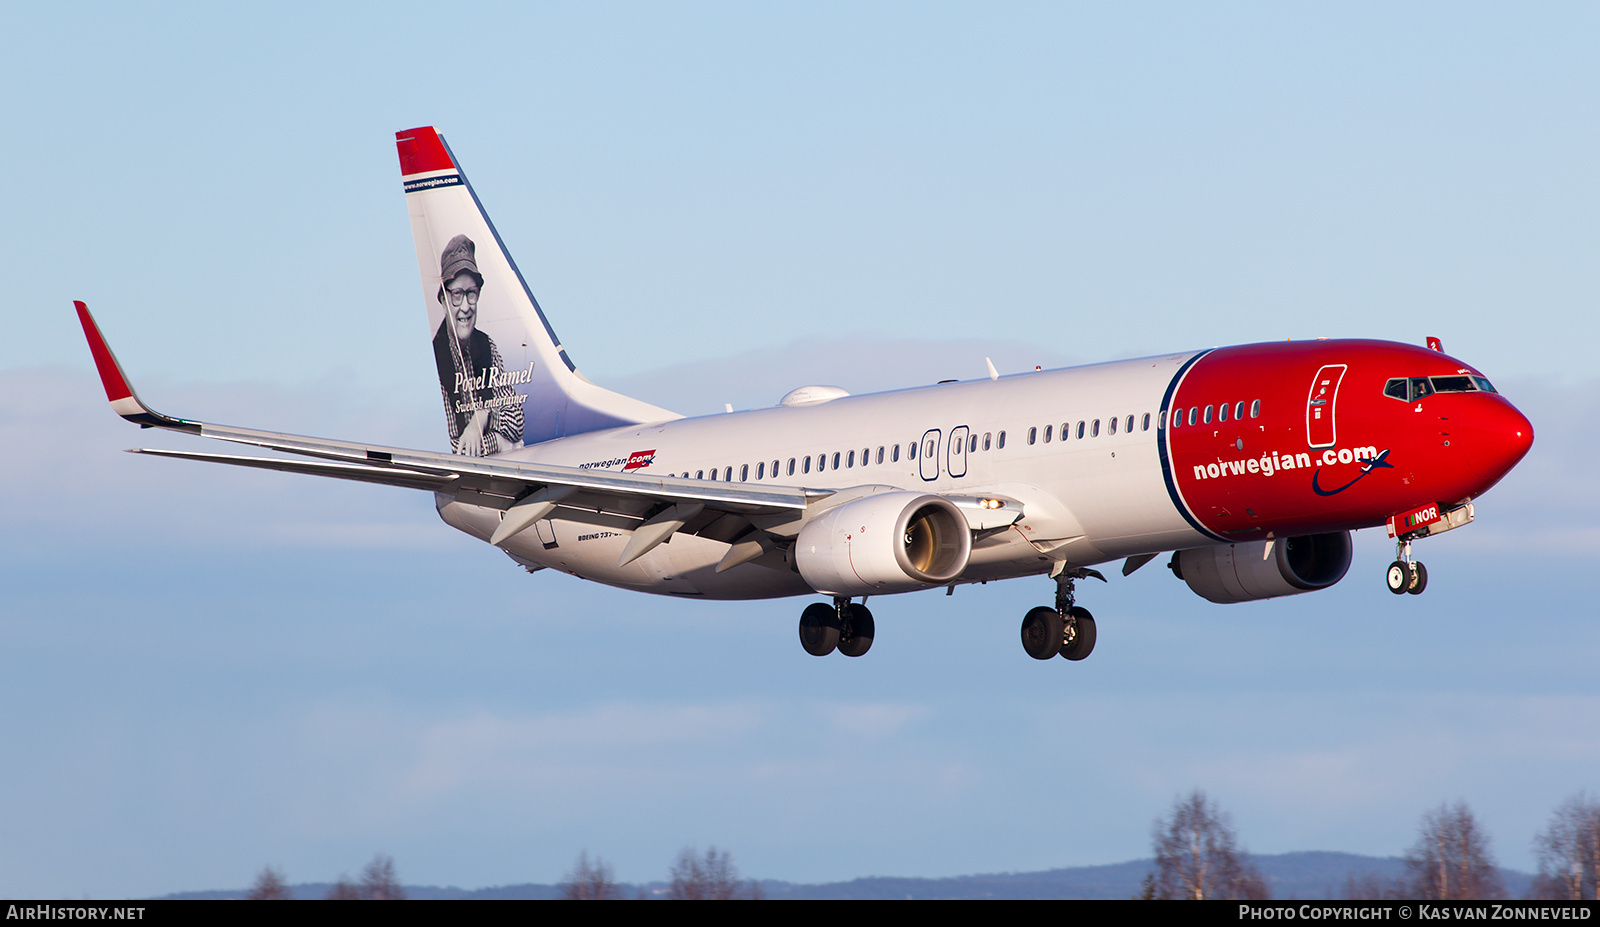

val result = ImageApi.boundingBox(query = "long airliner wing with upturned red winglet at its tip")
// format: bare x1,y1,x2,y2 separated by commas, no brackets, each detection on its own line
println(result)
74,301,812,520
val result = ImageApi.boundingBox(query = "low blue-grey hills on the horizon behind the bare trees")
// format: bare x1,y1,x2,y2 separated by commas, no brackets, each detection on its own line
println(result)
165,850,1533,901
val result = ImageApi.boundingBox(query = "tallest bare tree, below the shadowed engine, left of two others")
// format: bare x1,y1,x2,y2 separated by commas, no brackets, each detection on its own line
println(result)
1144,789,1269,901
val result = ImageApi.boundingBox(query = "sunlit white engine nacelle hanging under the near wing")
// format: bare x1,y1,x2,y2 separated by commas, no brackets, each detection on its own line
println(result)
794,493,973,596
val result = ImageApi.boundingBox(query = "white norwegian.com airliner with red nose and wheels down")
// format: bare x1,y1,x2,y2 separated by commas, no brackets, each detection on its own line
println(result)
77,128,1533,660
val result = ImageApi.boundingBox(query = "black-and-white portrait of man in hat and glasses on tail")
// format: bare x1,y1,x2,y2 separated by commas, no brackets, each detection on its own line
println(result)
434,235,523,456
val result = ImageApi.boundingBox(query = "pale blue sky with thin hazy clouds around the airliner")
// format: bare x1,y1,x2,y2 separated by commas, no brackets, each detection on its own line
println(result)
0,3,1600,897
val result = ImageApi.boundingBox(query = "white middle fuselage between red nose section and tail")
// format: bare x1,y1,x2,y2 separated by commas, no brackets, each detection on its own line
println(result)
440,352,1208,599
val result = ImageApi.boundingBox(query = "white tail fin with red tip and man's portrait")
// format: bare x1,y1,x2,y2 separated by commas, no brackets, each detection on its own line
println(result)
395,128,680,456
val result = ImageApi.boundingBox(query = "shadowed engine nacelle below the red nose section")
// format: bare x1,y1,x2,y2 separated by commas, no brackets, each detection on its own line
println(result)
1171,532,1350,604
